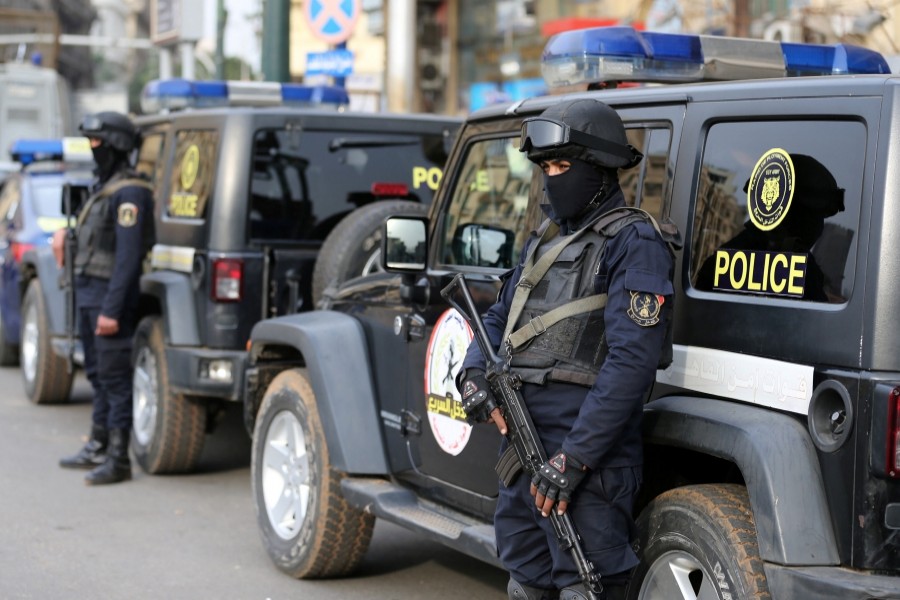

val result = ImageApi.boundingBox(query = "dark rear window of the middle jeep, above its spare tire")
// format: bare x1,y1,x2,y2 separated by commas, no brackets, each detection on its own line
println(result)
250,128,446,240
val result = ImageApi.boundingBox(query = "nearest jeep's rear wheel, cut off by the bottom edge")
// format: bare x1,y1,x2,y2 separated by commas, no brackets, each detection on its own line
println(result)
628,485,771,600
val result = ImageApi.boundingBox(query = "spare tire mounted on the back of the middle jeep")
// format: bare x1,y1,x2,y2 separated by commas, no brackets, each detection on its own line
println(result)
312,200,428,305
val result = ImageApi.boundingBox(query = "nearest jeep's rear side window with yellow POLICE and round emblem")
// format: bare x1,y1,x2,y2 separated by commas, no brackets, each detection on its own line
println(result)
690,121,866,303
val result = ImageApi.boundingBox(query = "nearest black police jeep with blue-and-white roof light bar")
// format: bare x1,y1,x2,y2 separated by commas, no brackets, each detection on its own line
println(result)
245,28,900,600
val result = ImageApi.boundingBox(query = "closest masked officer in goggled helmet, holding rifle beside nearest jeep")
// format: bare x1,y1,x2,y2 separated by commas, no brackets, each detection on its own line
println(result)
457,99,673,600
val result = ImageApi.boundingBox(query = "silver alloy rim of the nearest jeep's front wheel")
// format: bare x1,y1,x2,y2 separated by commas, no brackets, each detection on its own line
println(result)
260,410,312,540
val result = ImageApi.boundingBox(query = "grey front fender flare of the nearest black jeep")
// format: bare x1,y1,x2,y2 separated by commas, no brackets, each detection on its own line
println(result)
250,310,388,475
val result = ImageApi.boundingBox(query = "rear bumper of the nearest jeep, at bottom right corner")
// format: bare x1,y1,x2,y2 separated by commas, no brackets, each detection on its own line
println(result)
765,563,900,600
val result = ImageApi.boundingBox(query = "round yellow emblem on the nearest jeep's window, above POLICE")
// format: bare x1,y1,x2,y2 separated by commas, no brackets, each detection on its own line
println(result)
747,148,794,231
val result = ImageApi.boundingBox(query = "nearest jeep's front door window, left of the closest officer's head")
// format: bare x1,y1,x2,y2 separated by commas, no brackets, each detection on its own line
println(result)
437,136,537,269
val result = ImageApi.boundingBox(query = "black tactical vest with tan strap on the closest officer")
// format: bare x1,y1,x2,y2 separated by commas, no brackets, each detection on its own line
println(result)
504,207,671,387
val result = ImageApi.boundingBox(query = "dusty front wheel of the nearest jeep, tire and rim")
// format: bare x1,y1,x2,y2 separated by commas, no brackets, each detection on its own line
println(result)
250,369,375,578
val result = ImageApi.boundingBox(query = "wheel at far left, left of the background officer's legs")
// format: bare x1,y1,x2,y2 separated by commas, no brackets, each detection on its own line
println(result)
19,279,75,404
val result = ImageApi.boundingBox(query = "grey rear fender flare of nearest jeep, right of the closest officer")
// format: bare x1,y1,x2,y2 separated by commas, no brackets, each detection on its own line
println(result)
644,396,840,566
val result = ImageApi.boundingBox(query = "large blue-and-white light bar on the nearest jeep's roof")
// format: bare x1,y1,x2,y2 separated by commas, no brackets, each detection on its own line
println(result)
541,26,890,88
